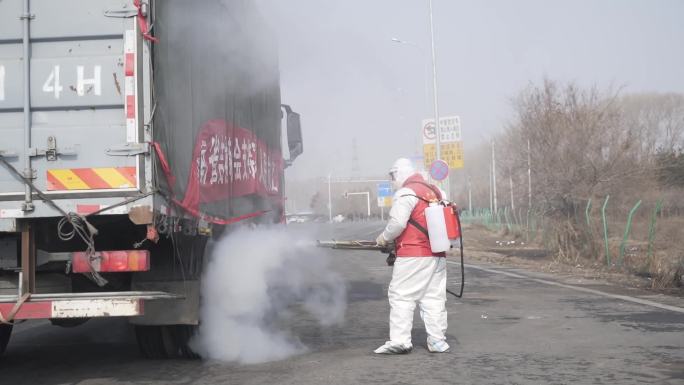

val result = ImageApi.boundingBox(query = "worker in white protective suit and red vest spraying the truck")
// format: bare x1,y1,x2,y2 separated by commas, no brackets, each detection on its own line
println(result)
374,158,449,354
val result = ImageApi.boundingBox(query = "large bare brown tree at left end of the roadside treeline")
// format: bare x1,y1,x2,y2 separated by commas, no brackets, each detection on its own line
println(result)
501,80,644,214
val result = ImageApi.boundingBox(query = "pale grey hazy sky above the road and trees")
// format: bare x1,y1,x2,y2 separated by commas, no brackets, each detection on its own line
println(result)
261,0,684,178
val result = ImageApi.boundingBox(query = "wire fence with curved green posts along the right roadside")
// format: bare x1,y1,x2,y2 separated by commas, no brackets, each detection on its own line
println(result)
461,195,684,274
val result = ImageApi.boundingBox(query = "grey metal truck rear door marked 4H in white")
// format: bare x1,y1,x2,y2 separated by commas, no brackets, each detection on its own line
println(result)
0,0,145,210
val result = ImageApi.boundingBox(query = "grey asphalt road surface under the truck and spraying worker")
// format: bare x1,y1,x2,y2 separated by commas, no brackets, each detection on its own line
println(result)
0,223,684,384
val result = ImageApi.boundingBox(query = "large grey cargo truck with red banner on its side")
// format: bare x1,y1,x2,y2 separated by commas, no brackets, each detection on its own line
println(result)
0,0,303,358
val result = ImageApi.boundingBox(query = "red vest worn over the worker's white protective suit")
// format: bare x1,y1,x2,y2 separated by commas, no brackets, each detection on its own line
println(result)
394,174,446,257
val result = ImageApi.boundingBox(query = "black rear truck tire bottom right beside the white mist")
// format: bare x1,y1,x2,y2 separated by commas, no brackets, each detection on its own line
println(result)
135,325,200,360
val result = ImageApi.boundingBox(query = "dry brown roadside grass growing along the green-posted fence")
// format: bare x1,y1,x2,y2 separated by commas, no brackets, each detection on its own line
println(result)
464,206,684,289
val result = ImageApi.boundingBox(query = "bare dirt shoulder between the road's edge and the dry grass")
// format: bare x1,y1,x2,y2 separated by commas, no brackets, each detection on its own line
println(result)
463,220,684,298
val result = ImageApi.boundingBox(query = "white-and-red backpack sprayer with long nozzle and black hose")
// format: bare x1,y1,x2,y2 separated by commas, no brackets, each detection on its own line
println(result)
318,201,465,298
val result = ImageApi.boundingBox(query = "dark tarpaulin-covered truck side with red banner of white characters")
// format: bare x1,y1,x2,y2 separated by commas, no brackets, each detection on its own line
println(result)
154,0,284,224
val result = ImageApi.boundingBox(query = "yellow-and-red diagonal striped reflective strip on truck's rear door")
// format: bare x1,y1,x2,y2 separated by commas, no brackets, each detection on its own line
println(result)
47,167,137,191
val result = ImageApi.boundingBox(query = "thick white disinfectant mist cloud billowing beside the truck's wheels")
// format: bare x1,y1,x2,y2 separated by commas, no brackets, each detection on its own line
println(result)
191,227,346,363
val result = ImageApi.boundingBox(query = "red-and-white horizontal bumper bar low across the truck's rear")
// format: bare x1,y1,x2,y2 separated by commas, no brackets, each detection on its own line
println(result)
0,291,183,320
